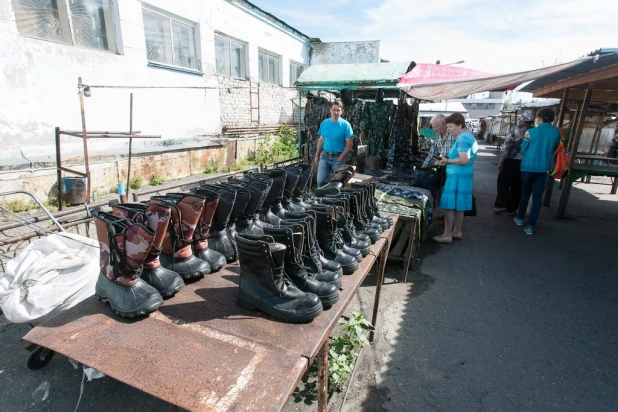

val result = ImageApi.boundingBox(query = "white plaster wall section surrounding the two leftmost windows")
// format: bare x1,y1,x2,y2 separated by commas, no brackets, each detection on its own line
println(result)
0,0,221,159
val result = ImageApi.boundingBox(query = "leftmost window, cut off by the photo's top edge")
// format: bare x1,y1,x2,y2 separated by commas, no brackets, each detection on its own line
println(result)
13,0,118,52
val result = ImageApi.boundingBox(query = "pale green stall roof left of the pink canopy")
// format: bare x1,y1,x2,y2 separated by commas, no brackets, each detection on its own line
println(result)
294,62,415,90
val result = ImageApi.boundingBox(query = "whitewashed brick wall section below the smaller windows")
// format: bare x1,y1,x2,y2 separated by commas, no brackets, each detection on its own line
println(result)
217,76,298,126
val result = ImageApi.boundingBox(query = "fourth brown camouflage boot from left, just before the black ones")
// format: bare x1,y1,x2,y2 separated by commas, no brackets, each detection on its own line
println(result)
193,188,227,272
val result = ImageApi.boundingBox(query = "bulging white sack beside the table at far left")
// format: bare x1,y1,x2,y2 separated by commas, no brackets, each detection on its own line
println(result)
0,233,100,323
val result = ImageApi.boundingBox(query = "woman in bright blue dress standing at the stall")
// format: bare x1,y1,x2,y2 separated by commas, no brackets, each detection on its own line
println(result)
433,113,478,243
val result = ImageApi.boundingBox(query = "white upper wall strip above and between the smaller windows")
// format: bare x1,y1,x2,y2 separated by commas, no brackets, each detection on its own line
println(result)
212,1,309,87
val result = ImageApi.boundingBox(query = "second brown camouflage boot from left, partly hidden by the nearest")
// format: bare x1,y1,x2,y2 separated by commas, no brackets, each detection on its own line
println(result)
112,203,185,298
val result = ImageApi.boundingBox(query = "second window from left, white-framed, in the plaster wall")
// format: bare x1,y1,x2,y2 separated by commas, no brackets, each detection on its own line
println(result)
142,4,201,71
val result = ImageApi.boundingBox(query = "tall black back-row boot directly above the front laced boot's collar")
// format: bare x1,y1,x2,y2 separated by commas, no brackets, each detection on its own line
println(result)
223,178,272,235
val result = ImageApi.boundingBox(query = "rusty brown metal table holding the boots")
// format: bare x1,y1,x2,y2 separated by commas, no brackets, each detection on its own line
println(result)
23,215,398,411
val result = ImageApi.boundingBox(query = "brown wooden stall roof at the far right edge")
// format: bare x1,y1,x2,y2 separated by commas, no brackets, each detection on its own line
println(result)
522,48,618,102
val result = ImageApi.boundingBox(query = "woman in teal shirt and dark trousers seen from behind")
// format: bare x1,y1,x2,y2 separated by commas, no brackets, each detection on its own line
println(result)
514,109,560,235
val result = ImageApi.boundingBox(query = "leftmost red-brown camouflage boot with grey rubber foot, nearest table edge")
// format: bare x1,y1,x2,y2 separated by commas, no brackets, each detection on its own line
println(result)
94,212,163,318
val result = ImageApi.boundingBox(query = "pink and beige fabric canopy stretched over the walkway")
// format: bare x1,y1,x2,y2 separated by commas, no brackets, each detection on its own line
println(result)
399,57,591,100
